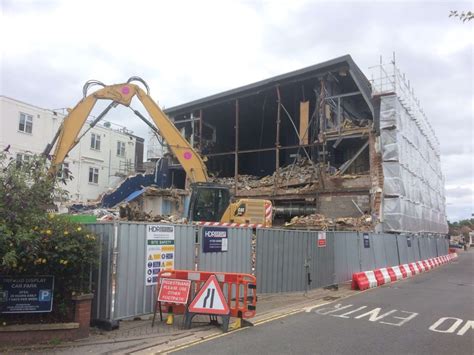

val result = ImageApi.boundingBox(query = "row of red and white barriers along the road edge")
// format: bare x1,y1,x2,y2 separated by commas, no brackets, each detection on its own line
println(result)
352,253,458,291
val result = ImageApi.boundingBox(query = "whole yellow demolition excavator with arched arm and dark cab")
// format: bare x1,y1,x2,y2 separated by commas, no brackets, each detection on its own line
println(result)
44,77,272,227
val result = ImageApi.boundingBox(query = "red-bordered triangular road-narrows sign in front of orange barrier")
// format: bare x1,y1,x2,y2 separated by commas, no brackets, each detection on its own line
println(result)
188,275,230,315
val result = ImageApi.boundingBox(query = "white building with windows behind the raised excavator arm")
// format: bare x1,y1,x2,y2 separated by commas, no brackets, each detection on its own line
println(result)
0,96,144,202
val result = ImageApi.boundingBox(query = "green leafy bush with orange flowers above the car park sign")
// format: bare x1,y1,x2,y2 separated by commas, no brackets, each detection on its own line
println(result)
0,153,98,320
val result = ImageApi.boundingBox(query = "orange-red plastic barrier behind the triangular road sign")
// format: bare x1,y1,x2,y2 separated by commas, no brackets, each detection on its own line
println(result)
155,270,257,319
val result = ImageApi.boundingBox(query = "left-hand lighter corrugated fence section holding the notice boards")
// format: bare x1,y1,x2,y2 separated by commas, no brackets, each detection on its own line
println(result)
87,222,253,320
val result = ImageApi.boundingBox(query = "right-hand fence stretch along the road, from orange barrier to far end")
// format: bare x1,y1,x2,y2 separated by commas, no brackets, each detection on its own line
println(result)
256,229,448,293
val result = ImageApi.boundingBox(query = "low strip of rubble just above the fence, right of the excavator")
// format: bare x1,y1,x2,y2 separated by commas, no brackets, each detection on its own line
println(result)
285,213,373,232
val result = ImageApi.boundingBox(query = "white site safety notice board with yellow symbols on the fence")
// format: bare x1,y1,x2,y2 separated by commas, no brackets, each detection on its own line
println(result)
145,224,175,286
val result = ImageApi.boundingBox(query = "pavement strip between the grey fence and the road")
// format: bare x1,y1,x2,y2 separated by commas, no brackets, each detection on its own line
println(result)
0,276,359,355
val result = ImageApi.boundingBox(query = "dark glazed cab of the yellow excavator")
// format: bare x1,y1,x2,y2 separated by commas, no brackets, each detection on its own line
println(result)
188,182,230,222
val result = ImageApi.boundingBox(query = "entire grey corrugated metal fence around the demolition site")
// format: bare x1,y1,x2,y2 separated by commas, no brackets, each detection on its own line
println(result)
87,222,448,320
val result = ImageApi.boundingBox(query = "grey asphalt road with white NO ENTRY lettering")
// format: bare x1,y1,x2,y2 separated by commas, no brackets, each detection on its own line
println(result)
173,249,474,355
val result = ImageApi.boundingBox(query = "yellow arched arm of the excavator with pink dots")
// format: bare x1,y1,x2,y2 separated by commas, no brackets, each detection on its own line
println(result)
51,79,208,182
